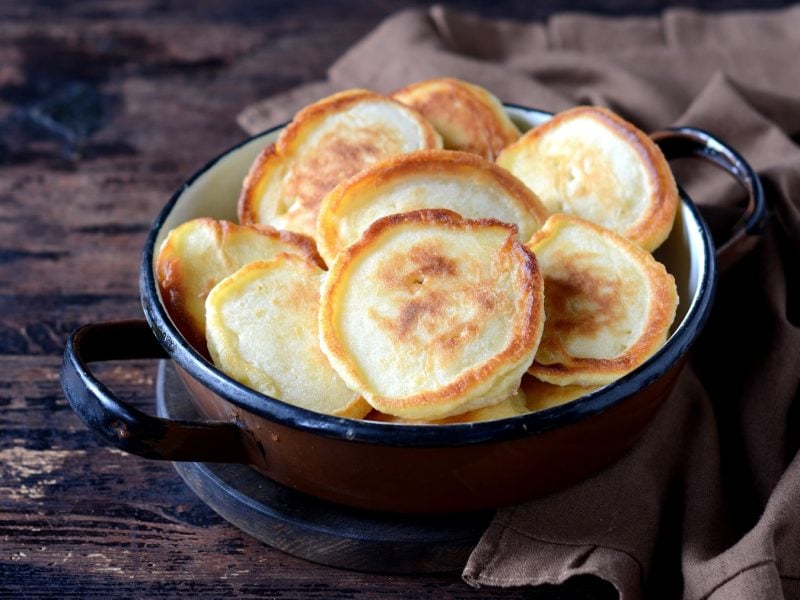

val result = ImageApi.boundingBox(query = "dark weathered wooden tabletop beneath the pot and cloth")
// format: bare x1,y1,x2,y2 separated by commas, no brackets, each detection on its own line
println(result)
0,0,786,599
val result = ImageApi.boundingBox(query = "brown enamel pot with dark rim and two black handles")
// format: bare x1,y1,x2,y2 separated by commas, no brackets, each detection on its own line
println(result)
62,106,765,513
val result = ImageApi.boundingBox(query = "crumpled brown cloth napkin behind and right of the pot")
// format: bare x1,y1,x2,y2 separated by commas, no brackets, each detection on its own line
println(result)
239,6,800,600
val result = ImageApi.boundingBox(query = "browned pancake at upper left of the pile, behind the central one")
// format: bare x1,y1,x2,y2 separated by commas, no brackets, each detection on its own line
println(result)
238,90,441,237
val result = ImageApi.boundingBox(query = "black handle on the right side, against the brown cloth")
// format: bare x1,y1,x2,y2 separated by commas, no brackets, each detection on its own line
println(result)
650,127,767,269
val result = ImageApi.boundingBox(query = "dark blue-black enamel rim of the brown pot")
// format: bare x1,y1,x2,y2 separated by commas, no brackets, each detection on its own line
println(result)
139,104,717,447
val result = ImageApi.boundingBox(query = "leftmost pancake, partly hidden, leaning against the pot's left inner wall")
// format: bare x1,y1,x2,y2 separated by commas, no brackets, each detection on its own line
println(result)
155,217,324,355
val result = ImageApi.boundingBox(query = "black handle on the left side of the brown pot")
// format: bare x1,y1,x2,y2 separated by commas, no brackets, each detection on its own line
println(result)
61,319,249,463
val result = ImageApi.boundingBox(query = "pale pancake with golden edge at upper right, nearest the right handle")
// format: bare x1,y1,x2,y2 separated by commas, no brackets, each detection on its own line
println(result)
497,106,678,252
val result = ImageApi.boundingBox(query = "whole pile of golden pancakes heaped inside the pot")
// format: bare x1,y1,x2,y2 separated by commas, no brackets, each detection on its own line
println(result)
156,78,678,424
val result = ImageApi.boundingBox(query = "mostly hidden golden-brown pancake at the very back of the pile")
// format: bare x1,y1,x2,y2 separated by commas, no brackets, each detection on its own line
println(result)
392,77,520,160
